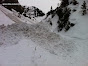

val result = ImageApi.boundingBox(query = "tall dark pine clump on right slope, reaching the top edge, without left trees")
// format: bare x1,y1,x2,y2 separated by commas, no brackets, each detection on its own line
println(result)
50,0,76,32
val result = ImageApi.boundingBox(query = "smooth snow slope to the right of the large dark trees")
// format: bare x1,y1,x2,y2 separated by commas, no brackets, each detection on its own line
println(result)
61,0,88,39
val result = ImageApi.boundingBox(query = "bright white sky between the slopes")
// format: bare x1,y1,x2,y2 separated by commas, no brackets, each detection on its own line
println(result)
19,0,60,13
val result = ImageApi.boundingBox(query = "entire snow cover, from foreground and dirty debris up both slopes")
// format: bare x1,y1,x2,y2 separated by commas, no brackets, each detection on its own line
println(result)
0,1,88,66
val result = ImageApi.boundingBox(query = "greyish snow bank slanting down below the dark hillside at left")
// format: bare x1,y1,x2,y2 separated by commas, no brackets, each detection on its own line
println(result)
0,6,37,24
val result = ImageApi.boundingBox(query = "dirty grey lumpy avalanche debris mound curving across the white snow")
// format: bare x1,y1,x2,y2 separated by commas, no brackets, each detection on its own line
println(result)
0,23,76,56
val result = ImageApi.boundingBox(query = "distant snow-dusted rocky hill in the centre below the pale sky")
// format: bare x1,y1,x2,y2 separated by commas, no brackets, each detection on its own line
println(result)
23,6,45,19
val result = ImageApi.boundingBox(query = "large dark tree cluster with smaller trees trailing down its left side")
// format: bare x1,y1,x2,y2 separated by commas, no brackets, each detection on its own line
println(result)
45,0,76,32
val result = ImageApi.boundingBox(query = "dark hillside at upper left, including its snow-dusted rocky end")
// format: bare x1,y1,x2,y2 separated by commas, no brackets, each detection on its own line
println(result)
0,0,45,19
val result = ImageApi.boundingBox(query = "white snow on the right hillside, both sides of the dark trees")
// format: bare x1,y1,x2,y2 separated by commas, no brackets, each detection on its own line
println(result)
44,0,88,39
